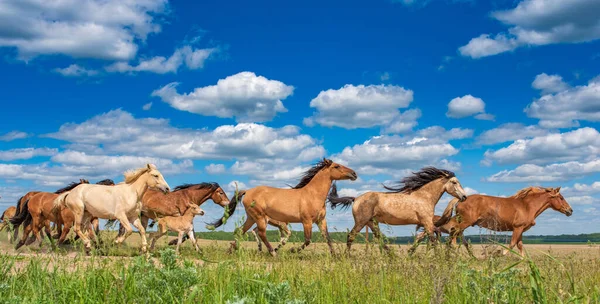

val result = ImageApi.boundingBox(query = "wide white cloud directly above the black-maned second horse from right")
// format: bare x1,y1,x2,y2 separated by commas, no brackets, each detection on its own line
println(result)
333,126,472,175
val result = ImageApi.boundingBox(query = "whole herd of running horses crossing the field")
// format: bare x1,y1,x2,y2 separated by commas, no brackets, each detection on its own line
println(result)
0,159,573,256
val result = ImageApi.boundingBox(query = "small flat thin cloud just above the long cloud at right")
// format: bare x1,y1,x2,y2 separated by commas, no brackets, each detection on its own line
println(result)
477,123,550,145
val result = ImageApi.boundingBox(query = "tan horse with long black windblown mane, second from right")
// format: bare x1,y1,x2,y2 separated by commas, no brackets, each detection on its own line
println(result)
329,167,467,252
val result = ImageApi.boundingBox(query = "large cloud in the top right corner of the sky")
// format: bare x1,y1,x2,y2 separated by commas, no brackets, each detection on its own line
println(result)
459,0,600,58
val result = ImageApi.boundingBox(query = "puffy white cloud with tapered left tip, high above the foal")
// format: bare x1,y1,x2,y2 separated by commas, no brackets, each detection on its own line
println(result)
152,72,294,122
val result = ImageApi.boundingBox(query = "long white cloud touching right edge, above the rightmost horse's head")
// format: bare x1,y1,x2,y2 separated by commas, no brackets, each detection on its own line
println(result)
484,128,600,164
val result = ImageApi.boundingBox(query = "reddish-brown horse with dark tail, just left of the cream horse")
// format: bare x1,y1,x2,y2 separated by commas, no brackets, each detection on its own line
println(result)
10,179,89,249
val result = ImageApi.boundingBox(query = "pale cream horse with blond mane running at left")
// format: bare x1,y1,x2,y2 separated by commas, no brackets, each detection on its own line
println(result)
54,164,170,254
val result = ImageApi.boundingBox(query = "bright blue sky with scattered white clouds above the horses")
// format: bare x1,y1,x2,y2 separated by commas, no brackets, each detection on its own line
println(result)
0,0,600,235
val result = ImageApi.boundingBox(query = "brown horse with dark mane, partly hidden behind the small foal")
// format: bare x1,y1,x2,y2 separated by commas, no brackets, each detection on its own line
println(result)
113,183,229,245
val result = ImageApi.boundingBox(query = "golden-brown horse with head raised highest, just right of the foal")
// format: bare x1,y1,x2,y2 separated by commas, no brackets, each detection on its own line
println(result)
217,159,358,256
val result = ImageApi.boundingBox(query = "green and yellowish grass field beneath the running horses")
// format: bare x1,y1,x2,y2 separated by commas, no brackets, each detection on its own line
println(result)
0,233,600,303
